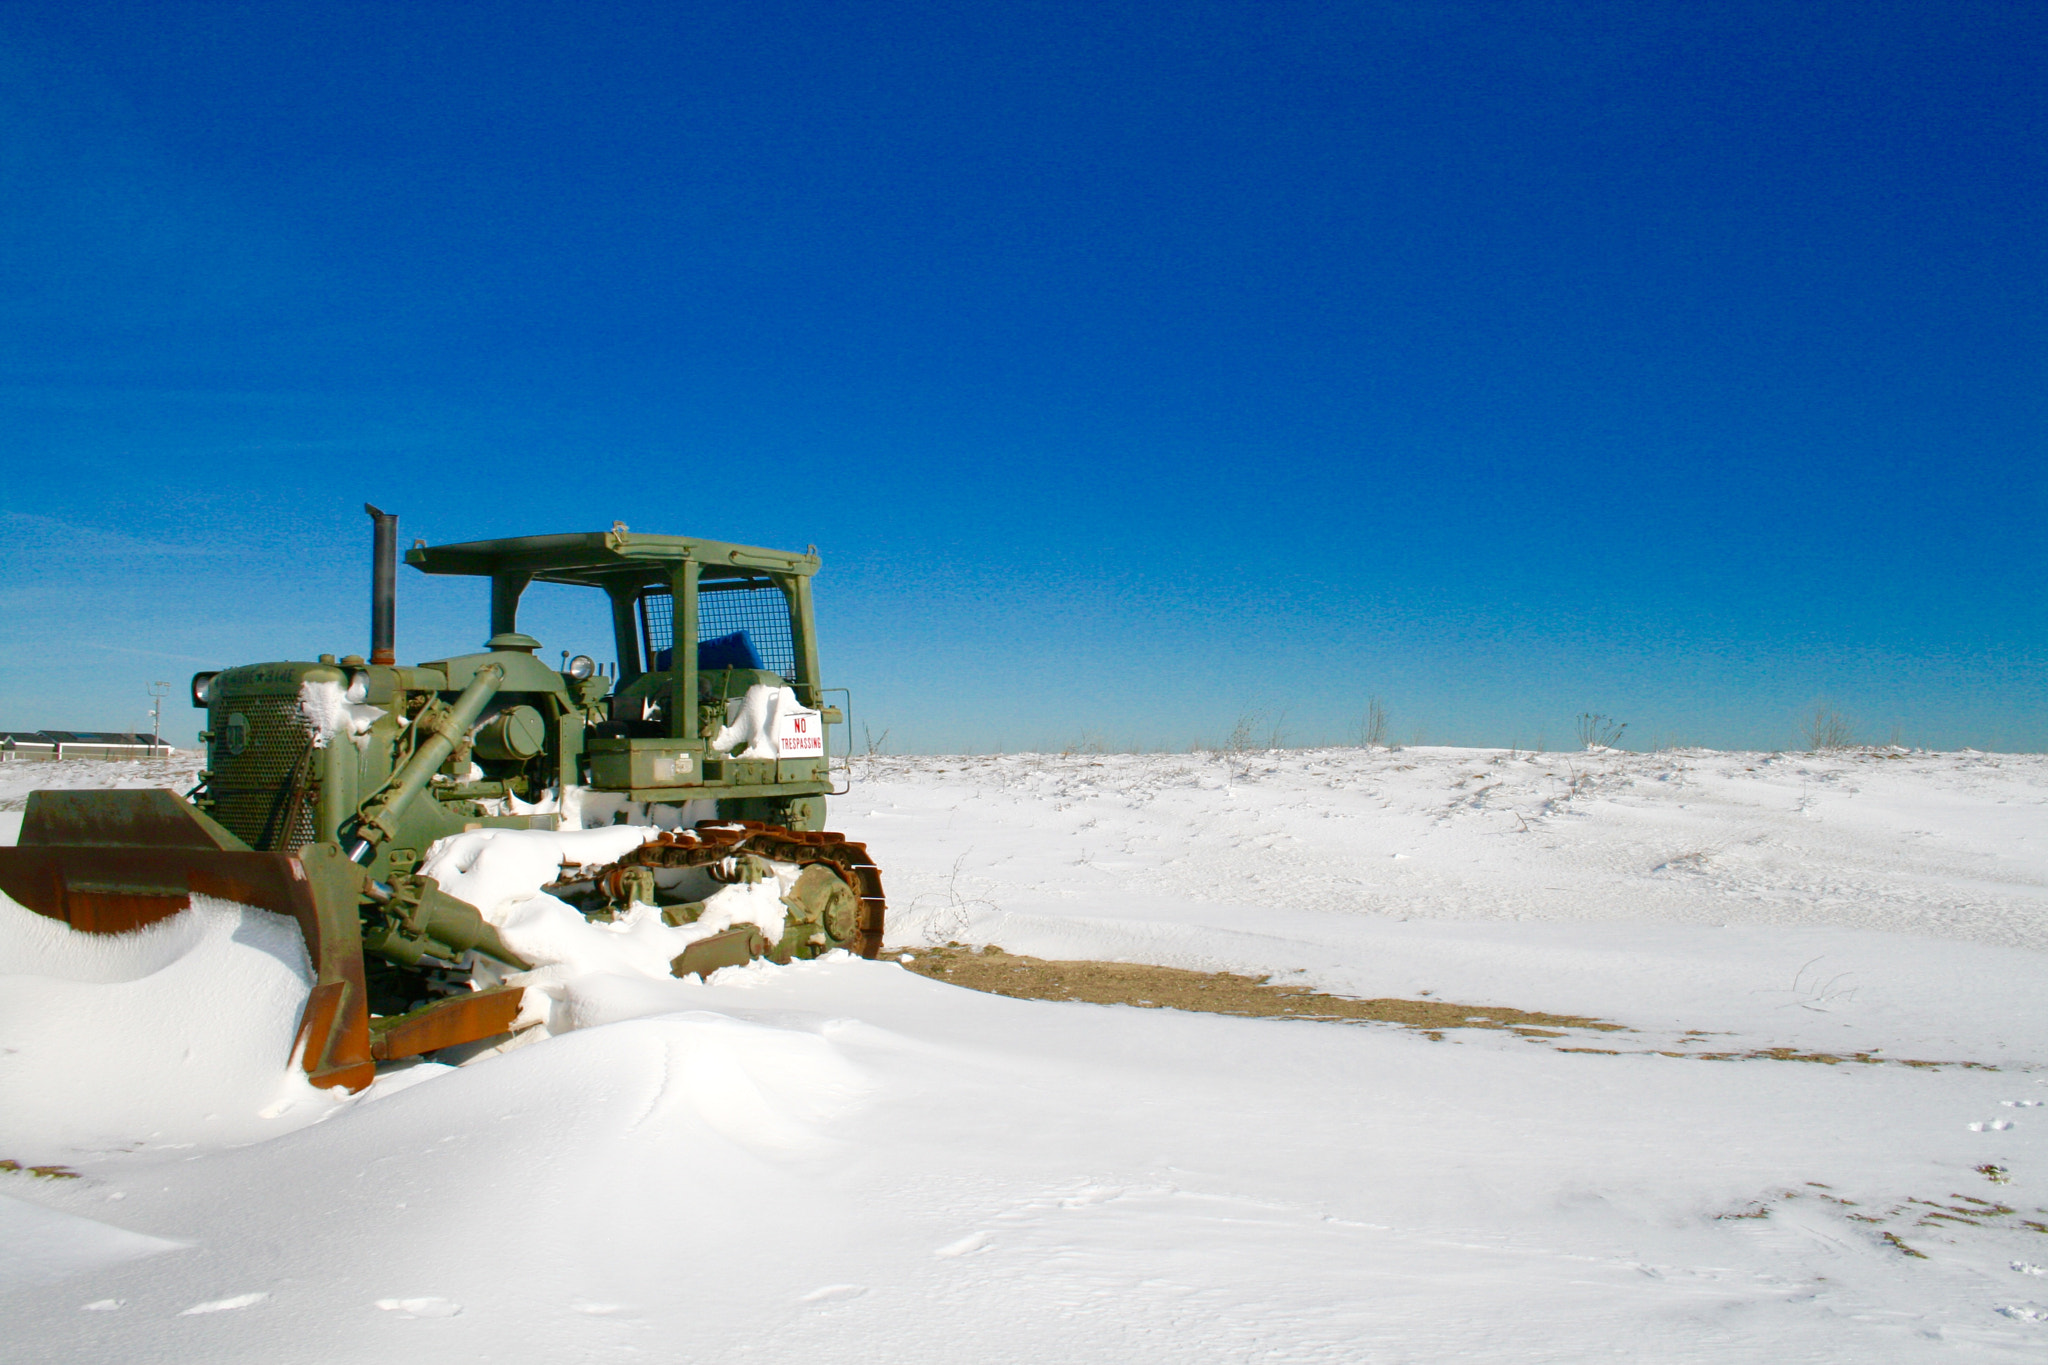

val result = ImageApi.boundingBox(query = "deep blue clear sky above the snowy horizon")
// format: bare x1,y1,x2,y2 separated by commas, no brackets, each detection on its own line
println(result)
0,0,2048,751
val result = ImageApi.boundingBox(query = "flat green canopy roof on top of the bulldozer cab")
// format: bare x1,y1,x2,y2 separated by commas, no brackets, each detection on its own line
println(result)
406,530,817,587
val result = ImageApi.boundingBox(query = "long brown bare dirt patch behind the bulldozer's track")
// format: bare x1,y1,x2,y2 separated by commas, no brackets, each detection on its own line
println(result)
905,943,1622,1038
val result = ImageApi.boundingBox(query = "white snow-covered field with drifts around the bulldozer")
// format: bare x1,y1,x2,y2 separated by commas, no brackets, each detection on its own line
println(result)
0,749,2048,1363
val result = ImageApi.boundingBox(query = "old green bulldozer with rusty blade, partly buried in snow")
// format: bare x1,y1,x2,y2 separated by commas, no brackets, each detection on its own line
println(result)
0,505,887,1091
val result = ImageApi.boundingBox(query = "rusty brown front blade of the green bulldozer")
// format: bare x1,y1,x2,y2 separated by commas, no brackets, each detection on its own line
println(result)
0,790,377,1091
